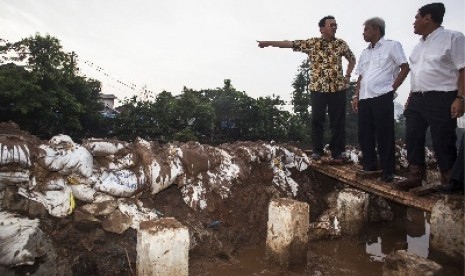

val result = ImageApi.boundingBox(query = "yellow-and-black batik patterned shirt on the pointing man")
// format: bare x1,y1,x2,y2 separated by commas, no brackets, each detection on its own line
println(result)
293,37,355,92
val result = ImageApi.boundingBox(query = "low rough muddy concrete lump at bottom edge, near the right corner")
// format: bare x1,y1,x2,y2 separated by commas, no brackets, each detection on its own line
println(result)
383,250,444,276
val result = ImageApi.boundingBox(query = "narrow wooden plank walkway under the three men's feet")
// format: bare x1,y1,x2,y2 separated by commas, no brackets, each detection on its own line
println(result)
310,162,442,212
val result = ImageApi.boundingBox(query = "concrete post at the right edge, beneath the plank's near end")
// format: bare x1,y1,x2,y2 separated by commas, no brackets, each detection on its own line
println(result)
430,200,465,260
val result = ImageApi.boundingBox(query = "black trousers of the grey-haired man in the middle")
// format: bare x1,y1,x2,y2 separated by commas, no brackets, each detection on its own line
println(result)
358,92,395,174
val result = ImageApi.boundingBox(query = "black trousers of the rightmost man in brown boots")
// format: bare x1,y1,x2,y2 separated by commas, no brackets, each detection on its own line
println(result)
404,91,457,171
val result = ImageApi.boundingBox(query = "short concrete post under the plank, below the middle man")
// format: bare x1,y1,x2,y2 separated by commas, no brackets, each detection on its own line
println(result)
336,188,369,235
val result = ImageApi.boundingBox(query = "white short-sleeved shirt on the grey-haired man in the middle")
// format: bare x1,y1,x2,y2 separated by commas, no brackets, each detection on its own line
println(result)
355,38,407,100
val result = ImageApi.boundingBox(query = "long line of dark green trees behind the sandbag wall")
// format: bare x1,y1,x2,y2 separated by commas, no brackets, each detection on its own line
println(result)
0,34,401,148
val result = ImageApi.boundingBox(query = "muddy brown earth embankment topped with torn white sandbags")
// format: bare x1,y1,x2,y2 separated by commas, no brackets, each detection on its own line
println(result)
0,124,323,275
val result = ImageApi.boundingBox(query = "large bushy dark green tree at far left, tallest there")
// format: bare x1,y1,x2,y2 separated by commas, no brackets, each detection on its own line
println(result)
0,34,103,138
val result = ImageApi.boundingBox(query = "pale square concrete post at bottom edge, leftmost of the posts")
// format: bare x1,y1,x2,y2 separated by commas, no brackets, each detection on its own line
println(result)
136,218,189,276
